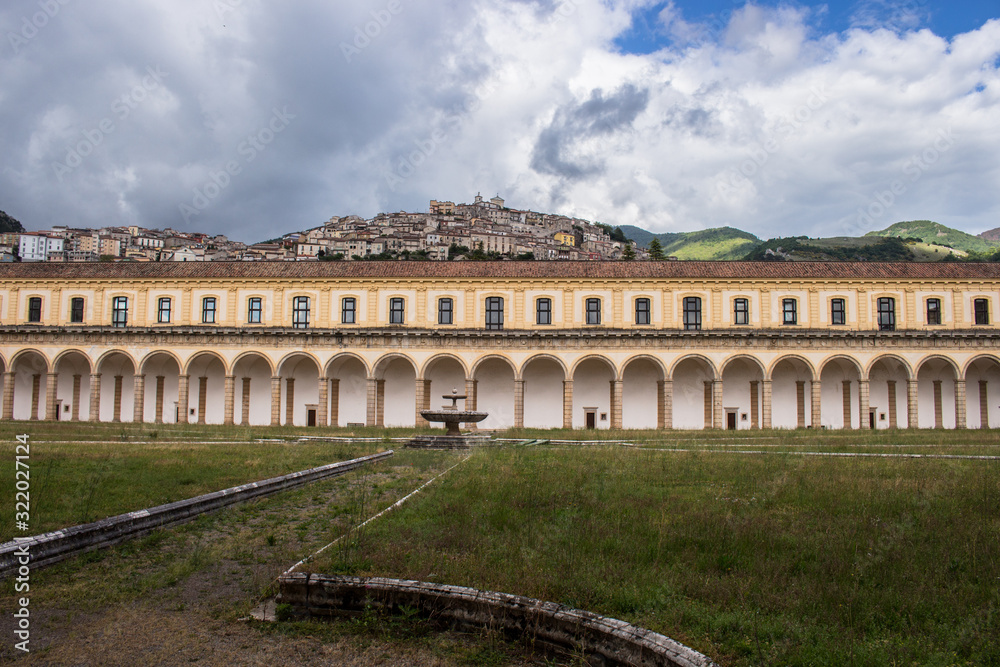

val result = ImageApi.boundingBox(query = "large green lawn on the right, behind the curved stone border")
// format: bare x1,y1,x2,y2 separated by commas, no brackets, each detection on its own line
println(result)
311,440,1000,665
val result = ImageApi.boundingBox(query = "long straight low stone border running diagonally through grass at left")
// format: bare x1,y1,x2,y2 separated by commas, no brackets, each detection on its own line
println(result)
0,449,395,579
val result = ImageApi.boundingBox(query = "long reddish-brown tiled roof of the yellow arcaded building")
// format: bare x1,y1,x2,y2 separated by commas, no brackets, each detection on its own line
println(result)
0,261,1000,280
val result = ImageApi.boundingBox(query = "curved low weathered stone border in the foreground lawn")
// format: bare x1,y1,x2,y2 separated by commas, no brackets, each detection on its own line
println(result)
277,573,715,667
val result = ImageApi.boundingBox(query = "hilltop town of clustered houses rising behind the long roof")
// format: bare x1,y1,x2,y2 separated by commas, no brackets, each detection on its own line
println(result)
0,194,632,262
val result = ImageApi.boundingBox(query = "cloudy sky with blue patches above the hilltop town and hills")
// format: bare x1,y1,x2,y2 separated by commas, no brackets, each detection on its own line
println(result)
0,0,1000,241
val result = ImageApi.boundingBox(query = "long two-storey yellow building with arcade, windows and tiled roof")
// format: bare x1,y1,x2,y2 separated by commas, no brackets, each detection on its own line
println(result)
0,262,1000,429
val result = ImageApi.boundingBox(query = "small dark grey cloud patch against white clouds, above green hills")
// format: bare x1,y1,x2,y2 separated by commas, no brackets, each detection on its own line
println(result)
531,84,649,180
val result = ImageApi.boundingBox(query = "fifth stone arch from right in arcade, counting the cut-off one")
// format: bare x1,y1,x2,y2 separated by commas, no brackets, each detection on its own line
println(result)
766,354,821,428
